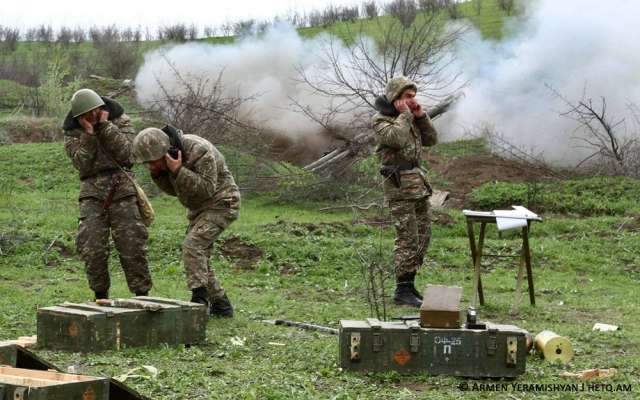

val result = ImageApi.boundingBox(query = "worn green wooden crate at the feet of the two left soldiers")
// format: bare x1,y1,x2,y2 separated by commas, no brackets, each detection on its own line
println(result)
37,297,208,352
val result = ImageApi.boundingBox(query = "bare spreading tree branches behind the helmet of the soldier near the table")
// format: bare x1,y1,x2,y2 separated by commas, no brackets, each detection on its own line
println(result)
298,15,464,109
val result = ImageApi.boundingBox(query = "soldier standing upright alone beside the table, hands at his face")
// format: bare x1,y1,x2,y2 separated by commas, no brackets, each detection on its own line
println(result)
372,77,437,307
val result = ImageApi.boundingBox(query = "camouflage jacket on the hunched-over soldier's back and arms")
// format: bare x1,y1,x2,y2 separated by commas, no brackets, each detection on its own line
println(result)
152,135,240,219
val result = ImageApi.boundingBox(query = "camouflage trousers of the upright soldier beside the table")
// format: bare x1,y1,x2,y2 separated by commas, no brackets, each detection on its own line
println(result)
389,197,431,278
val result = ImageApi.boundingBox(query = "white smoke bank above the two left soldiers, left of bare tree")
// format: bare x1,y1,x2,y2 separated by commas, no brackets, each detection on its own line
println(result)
136,24,356,137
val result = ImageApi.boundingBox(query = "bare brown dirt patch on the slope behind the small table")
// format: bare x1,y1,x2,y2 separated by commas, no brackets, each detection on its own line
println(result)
429,154,549,208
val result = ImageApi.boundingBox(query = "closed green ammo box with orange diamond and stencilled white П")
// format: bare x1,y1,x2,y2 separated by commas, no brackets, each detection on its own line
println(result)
339,319,526,378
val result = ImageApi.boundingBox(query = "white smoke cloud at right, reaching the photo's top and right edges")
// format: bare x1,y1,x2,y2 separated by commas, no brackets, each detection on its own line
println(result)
443,0,640,165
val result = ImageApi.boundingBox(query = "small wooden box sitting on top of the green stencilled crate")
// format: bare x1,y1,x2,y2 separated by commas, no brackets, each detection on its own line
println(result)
420,285,462,329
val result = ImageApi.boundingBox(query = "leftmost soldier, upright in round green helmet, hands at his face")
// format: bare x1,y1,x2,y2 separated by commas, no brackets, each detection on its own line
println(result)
63,89,152,299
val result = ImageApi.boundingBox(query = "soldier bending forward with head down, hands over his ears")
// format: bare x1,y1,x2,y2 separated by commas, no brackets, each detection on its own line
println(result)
133,127,240,317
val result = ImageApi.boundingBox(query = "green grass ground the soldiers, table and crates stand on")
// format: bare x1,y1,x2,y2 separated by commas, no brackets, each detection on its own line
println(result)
0,143,640,399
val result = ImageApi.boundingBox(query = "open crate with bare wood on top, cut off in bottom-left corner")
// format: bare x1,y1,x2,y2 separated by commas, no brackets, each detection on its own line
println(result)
0,367,109,400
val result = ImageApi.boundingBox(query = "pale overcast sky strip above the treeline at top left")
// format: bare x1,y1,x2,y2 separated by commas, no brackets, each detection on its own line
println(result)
0,0,363,29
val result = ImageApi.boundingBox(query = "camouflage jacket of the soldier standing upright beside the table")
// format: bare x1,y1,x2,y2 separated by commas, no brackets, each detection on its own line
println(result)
371,96,438,200
